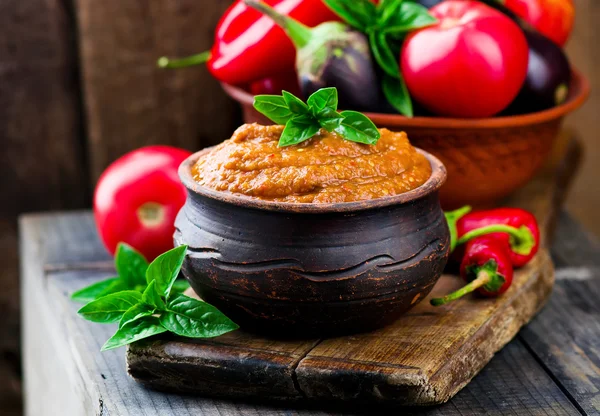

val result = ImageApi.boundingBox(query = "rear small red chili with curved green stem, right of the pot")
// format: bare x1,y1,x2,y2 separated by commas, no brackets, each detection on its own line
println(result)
456,208,540,268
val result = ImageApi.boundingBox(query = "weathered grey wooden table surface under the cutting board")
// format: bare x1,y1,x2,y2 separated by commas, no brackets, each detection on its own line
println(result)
20,212,600,416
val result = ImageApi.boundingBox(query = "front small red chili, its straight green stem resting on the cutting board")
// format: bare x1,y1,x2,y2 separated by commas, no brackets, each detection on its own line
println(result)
430,236,513,306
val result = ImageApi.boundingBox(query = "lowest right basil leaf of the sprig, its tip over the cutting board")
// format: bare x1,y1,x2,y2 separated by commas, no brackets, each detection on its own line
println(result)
160,295,239,338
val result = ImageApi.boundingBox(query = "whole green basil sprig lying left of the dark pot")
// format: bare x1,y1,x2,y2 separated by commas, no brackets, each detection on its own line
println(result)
72,244,238,351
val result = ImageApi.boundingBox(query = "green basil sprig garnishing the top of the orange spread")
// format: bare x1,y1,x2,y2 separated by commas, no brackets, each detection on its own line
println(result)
254,88,381,147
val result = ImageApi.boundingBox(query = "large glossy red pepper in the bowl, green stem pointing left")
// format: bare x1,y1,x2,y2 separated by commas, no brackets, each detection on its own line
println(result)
158,0,340,85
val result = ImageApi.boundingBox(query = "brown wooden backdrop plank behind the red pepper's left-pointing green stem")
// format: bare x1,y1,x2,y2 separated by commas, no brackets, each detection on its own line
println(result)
75,0,239,182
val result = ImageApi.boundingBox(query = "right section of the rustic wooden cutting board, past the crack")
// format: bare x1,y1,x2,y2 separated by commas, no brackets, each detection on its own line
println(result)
296,252,554,404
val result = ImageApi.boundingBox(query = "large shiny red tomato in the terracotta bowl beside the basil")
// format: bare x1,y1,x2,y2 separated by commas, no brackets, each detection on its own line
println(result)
400,0,528,117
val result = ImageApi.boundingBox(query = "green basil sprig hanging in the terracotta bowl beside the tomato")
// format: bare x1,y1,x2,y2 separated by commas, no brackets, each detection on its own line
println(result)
323,0,437,117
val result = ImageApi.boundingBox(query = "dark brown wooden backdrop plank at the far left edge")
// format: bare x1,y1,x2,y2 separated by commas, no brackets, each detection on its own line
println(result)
0,0,87,218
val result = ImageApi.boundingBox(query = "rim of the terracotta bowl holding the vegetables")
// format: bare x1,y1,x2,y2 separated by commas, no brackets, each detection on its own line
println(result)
221,69,590,129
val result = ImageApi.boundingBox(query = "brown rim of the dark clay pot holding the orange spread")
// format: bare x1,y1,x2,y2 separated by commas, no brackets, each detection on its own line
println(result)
179,147,447,214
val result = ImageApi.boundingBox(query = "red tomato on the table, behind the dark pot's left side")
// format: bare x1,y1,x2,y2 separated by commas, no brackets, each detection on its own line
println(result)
94,146,191,261
